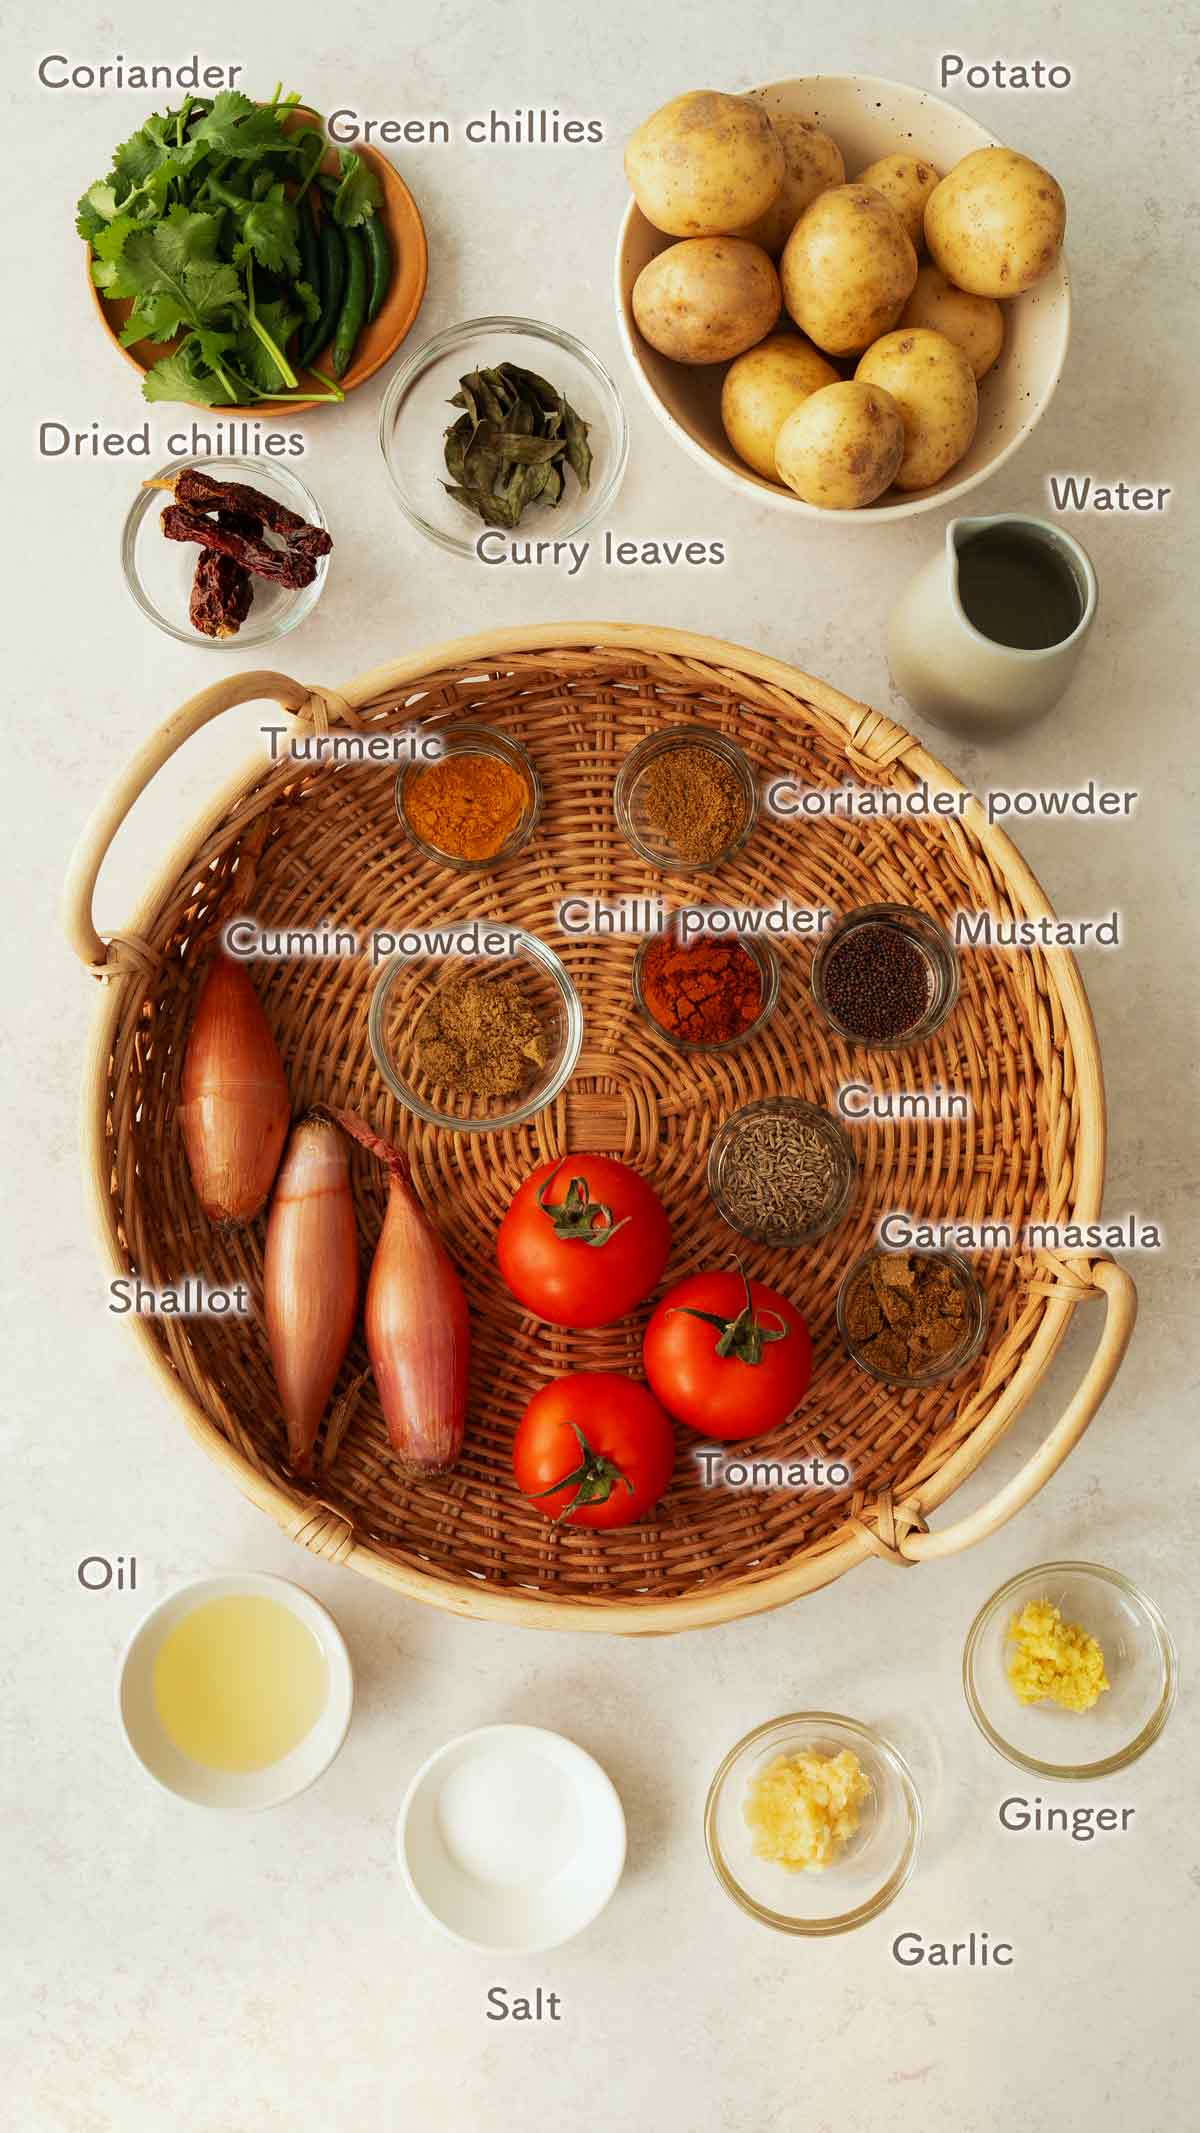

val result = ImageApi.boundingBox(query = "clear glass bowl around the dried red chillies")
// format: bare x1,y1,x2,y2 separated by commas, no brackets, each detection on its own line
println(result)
121,456,330,653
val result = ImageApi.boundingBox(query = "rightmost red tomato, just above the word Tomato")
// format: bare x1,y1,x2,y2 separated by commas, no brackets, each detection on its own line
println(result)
642,1273,812,1444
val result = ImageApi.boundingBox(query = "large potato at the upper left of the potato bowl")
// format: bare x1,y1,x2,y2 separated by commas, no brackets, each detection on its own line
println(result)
625,90,784,237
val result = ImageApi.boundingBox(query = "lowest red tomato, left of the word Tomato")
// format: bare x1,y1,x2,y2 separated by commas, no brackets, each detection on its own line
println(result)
512,1369,676,1527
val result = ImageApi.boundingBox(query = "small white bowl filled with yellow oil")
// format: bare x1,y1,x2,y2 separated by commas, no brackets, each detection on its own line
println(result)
117,1570,354,1809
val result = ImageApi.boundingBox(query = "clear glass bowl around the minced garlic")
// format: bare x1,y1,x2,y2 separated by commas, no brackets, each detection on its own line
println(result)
703,1711,921,1935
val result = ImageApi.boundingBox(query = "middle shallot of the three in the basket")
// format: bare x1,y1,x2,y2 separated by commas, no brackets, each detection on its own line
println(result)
262,1118,358,1474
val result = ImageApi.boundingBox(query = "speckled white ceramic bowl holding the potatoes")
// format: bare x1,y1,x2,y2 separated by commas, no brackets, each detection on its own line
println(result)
616,75,1070,525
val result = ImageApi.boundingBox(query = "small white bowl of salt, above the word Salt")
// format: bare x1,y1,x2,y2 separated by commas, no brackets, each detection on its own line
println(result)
396,1726,625,1956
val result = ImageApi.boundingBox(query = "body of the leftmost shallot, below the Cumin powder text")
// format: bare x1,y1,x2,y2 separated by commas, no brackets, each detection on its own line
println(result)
177,953,292,1226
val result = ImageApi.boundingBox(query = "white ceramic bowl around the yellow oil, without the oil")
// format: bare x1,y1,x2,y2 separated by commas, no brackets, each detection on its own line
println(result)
117,1570,354,1809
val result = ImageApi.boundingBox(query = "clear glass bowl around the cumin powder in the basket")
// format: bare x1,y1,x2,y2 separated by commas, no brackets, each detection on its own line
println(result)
367,919,584,1133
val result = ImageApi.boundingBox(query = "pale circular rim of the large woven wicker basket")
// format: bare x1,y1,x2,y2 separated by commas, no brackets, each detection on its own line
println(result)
77,623,1106,1634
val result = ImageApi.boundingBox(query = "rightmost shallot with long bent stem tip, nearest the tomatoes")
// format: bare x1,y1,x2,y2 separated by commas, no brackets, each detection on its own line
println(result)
333,1111,471,1474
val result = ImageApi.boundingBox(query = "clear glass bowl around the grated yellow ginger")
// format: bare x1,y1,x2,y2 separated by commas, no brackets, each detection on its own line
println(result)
963,1563,1177,1777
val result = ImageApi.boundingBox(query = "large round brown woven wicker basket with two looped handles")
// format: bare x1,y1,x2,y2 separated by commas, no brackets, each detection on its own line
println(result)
66,623,1136,1634
